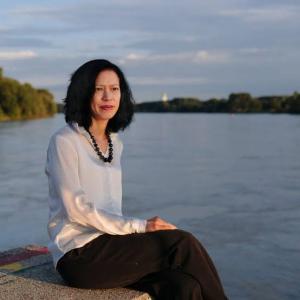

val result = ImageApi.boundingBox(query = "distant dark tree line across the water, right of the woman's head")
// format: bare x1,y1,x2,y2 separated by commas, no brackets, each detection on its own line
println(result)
135,92,300,114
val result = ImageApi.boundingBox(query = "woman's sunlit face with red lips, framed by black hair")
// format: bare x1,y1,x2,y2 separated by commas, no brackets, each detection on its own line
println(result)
91,70,121,121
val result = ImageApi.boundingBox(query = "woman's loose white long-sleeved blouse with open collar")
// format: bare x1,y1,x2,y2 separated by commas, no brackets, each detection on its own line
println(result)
45,122,147,267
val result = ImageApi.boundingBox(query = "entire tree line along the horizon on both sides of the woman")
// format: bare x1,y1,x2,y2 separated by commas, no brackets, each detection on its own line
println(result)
0,68,300,121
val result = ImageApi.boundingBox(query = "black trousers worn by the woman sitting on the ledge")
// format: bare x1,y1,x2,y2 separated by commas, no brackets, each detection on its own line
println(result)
57,229,228,300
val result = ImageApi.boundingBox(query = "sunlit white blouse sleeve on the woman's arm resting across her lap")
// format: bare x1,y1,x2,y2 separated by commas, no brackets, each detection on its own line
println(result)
46,135,147,235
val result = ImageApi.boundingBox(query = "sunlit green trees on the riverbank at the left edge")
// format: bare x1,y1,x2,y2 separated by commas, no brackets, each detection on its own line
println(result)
0,68,57,121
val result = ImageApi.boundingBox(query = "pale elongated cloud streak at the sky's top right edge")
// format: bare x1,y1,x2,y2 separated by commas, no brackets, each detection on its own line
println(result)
219,5,300,22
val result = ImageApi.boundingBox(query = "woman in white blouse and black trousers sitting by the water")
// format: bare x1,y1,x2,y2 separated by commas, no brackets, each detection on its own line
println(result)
46,60,226,300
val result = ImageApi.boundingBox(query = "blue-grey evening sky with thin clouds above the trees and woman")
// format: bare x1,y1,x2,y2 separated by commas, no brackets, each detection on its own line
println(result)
0,0,300,103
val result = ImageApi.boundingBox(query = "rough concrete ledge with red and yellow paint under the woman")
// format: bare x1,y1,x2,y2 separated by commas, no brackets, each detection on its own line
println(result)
0,245,151,300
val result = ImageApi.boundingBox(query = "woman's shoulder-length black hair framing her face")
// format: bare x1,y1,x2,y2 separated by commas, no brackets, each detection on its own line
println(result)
64,59,134,132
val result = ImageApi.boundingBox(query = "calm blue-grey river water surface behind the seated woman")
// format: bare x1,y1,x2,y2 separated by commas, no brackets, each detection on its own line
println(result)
0,114,300,300
